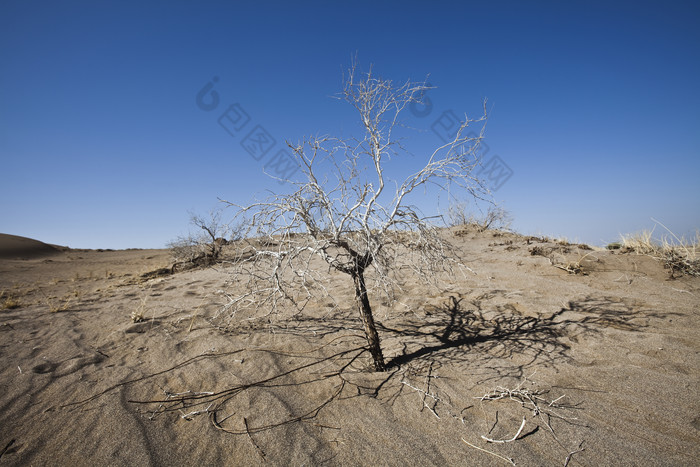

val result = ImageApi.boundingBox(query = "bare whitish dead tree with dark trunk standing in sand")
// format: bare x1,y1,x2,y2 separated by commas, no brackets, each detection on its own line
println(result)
221,64,488,371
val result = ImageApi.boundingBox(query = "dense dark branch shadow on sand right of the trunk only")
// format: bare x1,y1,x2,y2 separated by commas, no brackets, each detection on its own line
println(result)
381,291,661,377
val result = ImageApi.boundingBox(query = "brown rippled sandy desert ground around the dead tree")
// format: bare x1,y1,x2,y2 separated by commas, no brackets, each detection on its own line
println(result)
0,229,700,466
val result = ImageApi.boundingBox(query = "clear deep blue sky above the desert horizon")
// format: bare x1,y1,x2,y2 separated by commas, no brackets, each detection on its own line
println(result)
0,0,700,248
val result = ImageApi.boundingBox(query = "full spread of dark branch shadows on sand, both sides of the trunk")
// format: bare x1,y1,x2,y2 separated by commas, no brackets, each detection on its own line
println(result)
63,291,666,459
